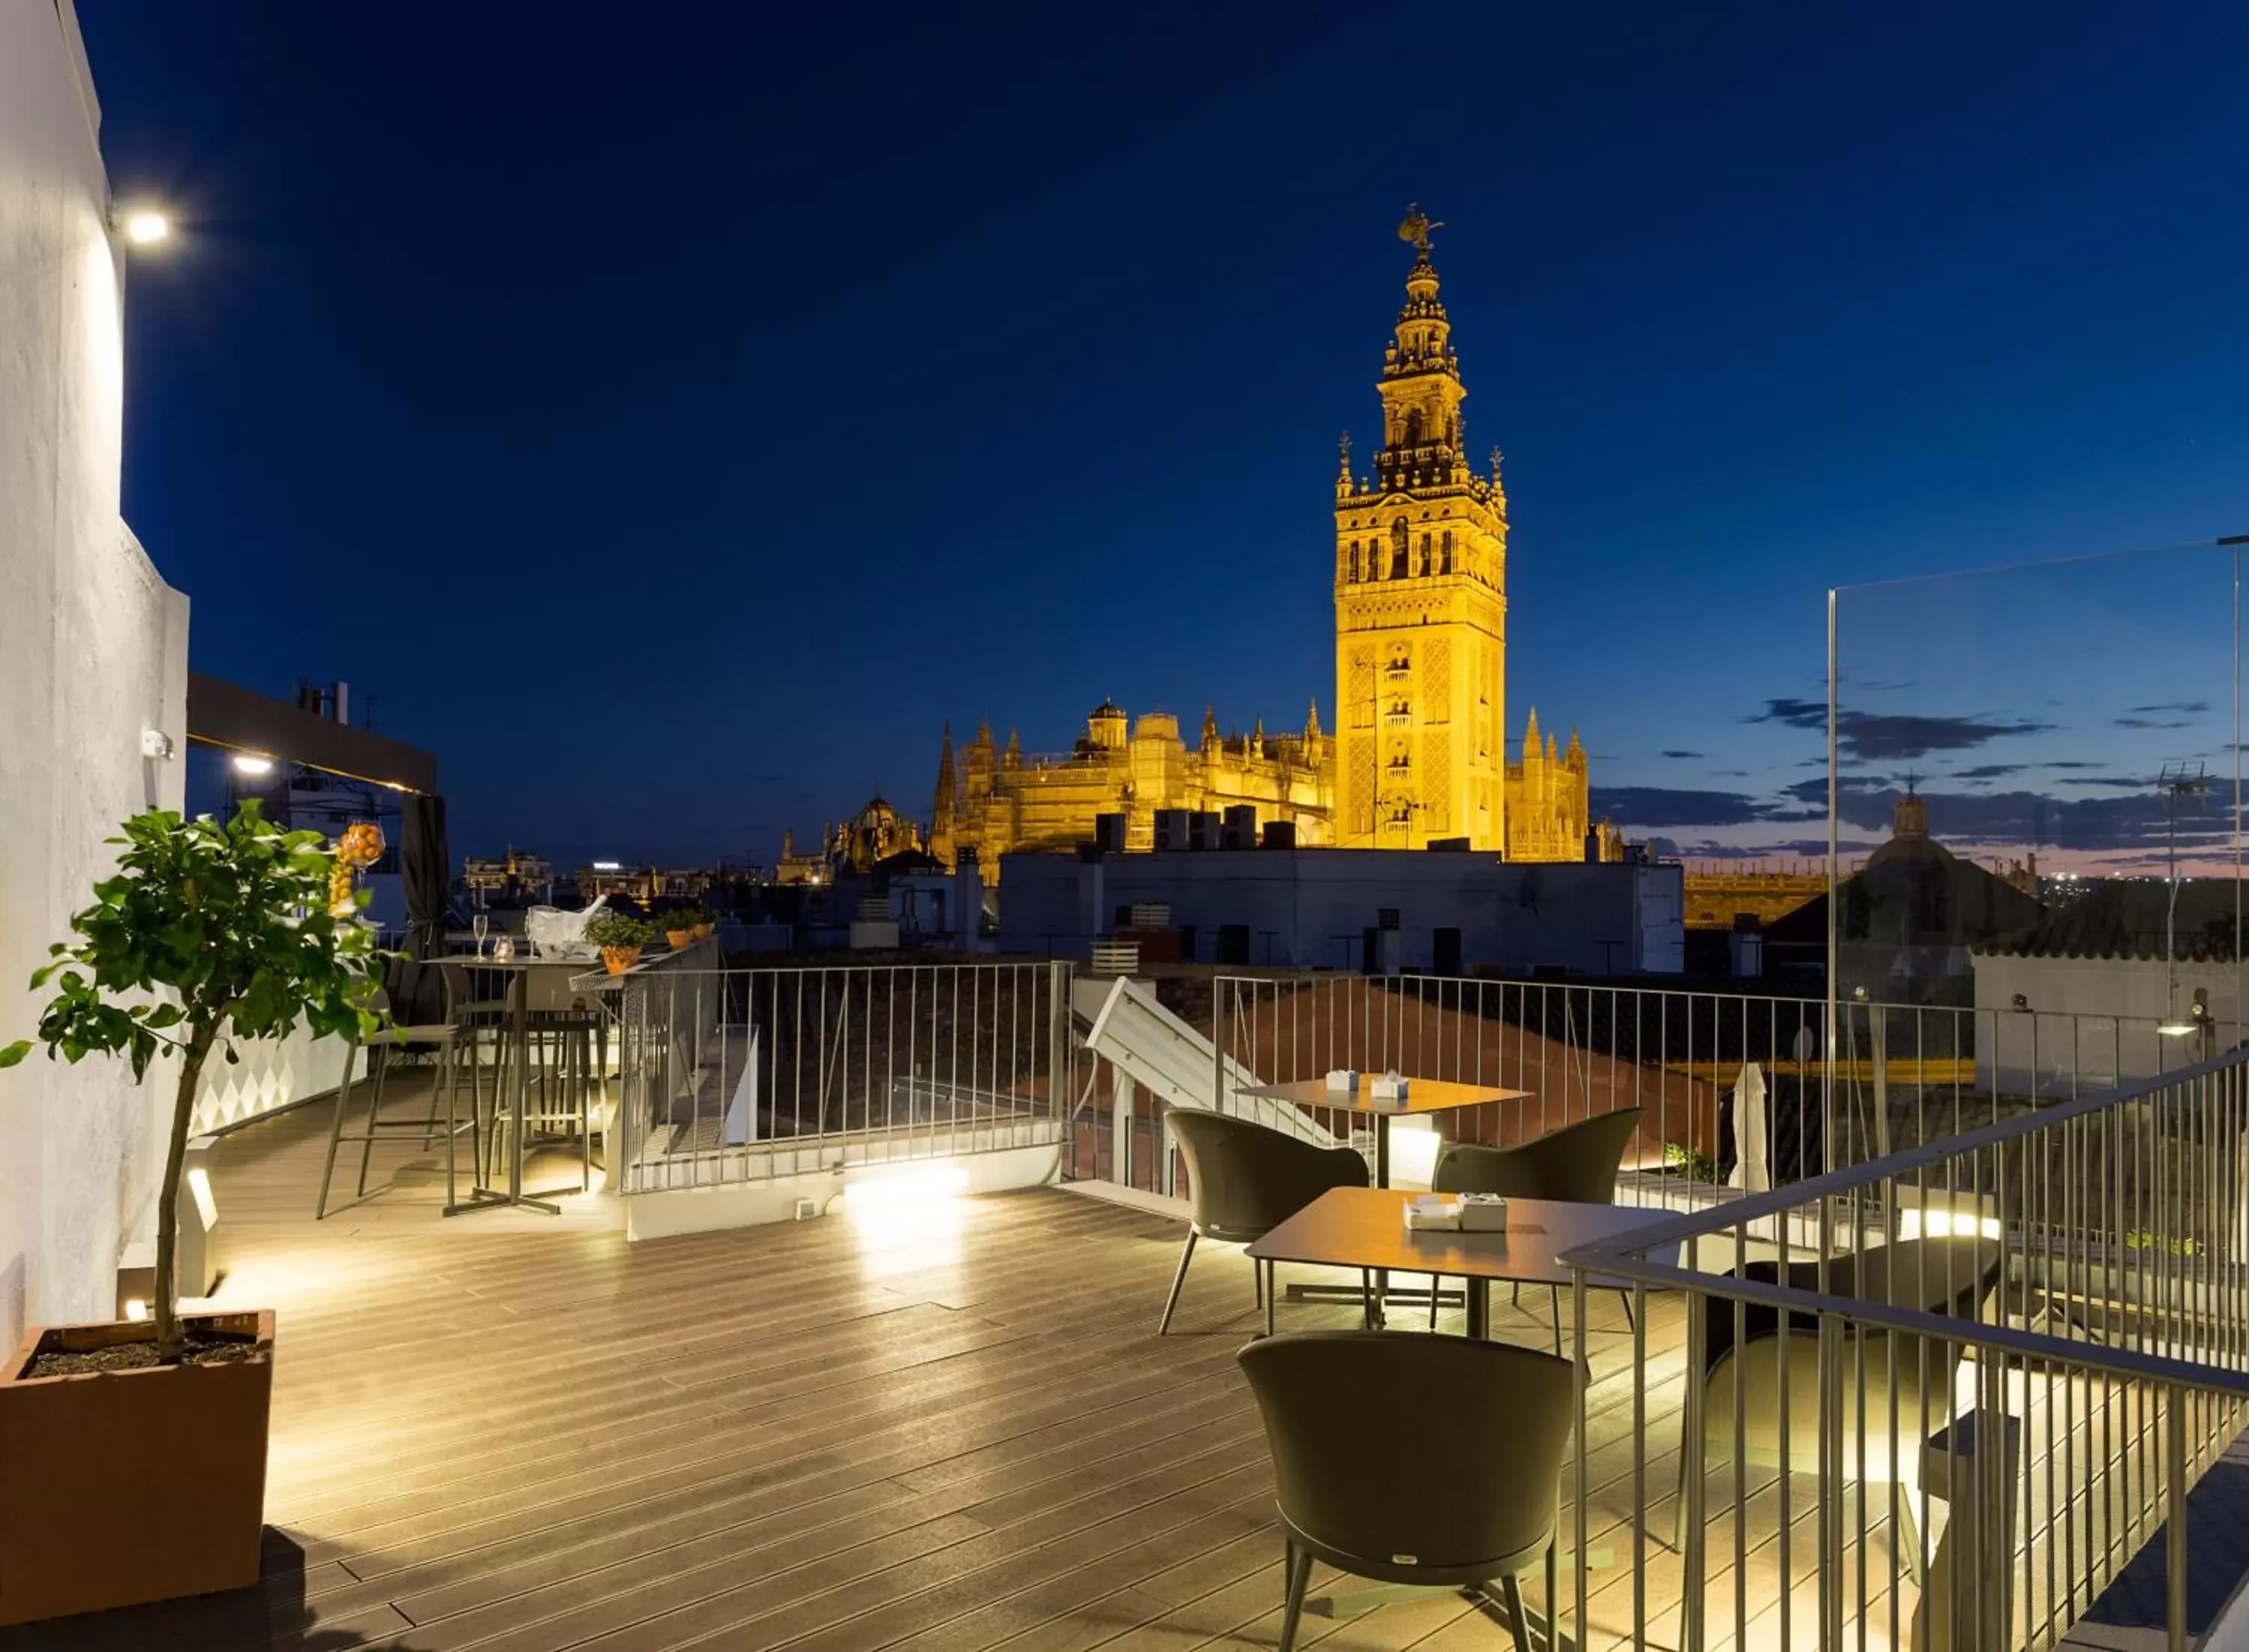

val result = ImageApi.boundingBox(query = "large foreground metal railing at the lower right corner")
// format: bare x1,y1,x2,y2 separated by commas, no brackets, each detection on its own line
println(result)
1561,1052,2249,1652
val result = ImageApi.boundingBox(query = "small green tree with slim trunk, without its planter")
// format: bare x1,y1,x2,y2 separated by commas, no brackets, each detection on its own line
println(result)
0,801,389,1360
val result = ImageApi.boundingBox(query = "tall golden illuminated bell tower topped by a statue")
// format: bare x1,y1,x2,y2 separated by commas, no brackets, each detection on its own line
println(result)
1336,209,1507,849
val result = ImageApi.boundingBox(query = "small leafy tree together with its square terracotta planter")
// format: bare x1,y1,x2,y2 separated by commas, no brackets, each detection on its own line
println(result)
0,803,385,1623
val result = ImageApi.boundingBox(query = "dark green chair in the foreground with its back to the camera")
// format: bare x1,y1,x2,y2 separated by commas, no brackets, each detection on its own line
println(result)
1237,1330,1577,1652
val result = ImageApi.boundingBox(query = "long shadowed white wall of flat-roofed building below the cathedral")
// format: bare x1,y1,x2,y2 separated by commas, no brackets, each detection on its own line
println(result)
999,849,1685,975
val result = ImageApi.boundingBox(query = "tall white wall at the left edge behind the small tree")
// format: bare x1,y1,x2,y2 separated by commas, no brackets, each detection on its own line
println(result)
0,0,187,1344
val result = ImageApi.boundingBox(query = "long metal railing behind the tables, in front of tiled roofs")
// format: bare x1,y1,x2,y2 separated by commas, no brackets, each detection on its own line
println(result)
1068,971,2240,1207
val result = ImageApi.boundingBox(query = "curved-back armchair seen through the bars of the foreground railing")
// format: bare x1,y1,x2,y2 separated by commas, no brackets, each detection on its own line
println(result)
1673,1234,2004,1573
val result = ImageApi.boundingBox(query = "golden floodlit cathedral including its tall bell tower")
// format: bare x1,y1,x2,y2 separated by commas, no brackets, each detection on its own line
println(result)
929,211,1622,881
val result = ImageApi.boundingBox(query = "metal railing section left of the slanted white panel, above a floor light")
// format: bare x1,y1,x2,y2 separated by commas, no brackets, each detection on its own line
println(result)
609,962,1073,1193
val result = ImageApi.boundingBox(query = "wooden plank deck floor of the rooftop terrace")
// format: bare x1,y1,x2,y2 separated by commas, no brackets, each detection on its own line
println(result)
0,1088,1673,1652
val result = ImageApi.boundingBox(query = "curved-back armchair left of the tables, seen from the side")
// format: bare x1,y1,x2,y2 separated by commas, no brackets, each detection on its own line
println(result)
1156,1106,1367,1337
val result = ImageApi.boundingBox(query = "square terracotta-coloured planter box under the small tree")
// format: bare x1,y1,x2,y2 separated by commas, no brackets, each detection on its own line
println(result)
0,1312,274,1623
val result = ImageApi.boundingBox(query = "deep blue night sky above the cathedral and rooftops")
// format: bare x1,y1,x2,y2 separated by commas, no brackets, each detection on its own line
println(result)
81,0,2249,860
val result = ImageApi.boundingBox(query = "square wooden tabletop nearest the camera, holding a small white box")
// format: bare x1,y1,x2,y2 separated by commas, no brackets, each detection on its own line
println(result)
1248,1187,1673,1285
